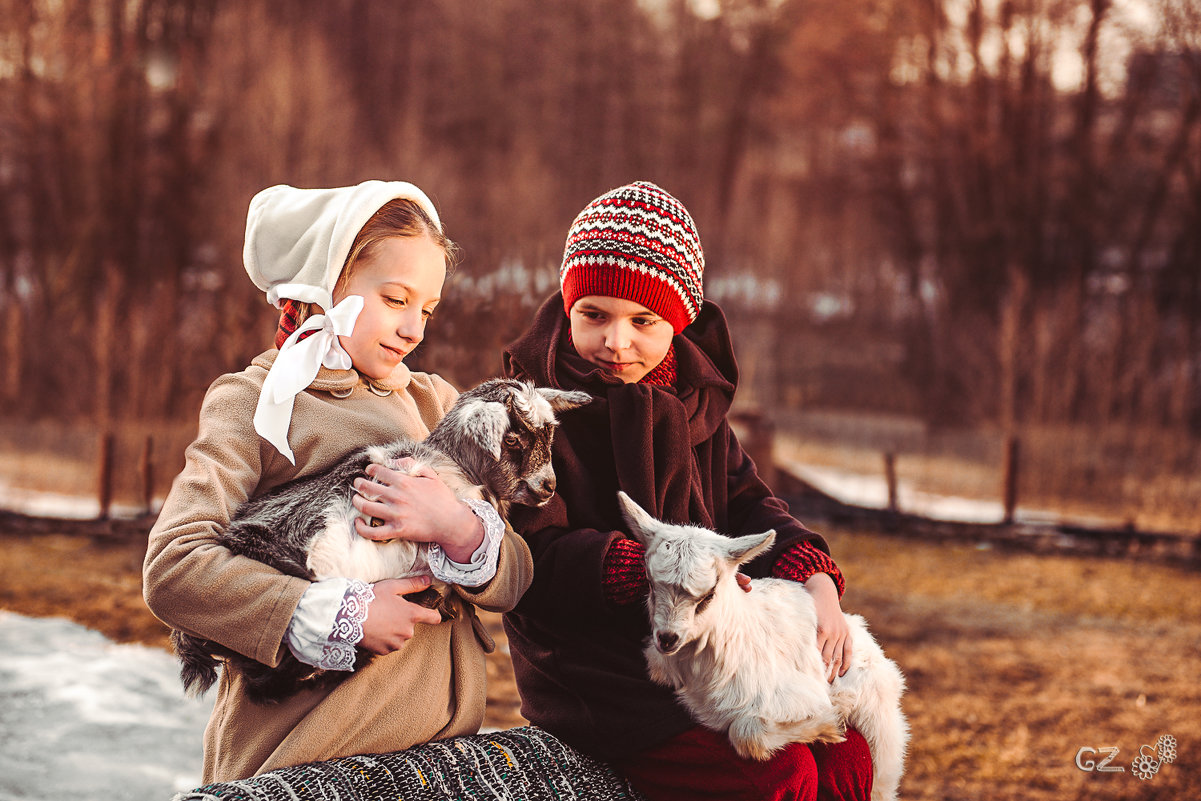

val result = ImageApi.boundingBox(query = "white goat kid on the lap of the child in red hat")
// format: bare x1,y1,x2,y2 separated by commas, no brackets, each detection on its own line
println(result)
617,492,909,801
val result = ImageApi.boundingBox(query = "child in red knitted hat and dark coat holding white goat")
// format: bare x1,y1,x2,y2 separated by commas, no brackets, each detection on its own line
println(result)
504,183,872,801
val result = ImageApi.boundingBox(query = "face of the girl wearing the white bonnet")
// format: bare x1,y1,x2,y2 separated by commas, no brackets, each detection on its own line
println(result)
334,237,447,381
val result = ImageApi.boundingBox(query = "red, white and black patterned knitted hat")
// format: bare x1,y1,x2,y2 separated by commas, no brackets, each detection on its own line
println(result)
558,181,705,334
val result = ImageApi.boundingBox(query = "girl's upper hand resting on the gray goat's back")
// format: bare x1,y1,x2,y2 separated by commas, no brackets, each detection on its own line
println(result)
351,459,484,563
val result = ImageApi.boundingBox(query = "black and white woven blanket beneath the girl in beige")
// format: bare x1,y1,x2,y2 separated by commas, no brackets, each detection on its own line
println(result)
173,727,641,801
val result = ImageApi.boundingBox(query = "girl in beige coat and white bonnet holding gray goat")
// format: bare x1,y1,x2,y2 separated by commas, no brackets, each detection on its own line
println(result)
143,181,532,782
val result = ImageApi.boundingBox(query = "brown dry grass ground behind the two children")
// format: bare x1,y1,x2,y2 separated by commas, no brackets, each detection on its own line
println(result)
0,523,1201,801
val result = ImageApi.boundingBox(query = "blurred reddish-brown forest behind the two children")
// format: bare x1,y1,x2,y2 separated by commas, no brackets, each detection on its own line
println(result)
0,0,1201,532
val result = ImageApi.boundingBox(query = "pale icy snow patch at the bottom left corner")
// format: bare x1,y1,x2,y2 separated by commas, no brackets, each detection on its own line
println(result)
0,610,213,801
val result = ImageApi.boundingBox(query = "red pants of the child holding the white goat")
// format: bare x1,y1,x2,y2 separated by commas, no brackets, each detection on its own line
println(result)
613,727,872,801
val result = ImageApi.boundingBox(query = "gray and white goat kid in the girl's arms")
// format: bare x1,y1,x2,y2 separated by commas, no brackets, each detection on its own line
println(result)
172,378,591,704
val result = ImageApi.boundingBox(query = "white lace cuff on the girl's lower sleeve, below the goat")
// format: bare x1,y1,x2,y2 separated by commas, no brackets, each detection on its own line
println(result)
287,579,375,670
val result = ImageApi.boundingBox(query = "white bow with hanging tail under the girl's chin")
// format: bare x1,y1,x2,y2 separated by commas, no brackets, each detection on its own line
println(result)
255,294,363,465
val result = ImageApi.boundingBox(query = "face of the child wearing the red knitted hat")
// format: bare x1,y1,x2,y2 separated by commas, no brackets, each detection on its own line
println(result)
568,294,675,384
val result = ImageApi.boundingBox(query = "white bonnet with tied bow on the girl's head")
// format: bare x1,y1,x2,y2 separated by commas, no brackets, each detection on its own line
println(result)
243,181,442,465
